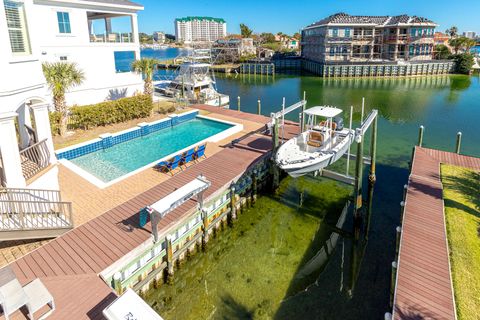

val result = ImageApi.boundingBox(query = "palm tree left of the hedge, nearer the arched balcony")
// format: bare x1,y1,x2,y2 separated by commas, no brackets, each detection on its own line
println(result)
42,62,85,136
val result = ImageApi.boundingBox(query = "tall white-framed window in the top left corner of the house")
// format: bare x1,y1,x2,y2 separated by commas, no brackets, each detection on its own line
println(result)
3,0,30,55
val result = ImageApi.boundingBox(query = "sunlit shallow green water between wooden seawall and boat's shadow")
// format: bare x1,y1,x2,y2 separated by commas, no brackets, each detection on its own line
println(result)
146,177,351,320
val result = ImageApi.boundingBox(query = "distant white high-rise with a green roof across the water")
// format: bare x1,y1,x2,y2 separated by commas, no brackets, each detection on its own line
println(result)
175,17,227,43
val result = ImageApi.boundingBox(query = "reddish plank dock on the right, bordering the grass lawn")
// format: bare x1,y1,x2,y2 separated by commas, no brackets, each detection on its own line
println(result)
393,147,480,320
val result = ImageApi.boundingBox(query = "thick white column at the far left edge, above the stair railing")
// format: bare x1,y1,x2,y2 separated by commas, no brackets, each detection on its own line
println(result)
0,112,26,188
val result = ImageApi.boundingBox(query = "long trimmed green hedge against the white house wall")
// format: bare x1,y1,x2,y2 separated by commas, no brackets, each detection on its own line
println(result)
50,95,153,134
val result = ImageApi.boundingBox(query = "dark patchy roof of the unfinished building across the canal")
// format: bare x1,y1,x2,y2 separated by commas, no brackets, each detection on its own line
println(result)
307,12,435,28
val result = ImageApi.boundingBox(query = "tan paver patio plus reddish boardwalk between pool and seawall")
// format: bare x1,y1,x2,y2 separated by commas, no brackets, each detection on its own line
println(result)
0,106,298,319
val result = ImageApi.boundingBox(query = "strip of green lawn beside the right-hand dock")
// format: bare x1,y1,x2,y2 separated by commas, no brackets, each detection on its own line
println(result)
441,165,480,320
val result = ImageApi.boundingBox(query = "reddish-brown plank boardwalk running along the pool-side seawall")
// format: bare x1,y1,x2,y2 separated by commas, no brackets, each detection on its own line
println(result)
0,109,280,319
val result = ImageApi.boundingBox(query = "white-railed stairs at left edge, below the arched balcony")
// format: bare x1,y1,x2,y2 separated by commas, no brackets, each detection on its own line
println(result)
0,188,73,241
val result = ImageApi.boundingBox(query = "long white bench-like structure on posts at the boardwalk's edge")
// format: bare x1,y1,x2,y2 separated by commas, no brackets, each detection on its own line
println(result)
139,175,211,242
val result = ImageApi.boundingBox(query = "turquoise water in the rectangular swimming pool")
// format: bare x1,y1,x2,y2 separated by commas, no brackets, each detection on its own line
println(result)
70,118,232,182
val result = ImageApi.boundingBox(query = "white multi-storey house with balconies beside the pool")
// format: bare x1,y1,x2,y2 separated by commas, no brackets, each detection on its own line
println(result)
0,0,143,190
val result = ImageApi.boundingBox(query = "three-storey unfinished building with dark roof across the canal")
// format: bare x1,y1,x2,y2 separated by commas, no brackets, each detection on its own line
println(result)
301,13,437,63
